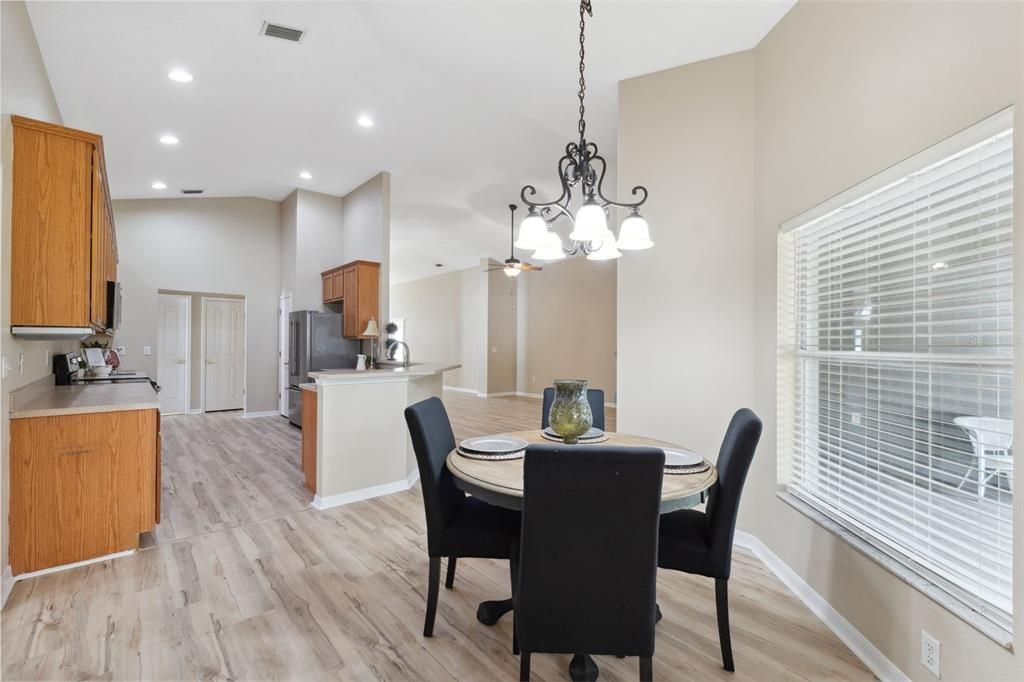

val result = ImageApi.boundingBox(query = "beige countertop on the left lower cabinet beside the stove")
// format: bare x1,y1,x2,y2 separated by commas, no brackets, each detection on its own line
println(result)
10,378,160,419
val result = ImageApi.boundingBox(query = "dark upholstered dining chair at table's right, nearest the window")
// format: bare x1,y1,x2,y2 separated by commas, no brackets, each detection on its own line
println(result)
657,408,761,672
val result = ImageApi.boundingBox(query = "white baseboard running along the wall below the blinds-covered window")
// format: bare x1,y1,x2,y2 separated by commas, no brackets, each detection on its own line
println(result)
734,530,910,682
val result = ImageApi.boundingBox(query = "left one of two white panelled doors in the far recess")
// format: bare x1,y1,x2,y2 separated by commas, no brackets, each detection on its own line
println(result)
157,294,191,415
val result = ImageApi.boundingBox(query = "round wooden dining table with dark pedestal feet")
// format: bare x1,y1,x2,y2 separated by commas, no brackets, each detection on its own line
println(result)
446,430,718,680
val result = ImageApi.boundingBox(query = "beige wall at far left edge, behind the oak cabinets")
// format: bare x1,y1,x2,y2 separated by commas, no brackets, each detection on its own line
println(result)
0,2,72,569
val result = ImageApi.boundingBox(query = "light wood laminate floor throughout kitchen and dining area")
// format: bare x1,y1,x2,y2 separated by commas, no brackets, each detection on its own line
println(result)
0,393,871,681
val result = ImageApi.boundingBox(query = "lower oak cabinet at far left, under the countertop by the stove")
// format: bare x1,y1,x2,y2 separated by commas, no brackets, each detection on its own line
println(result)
10,410,160,574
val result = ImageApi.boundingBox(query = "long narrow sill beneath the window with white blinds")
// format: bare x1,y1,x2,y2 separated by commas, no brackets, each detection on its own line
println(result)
776,491,1014,651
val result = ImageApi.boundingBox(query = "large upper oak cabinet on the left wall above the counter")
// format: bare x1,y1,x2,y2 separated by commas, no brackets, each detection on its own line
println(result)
10,116,117,331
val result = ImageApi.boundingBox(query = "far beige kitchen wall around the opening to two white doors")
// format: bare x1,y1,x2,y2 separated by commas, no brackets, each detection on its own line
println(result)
114,193,282,412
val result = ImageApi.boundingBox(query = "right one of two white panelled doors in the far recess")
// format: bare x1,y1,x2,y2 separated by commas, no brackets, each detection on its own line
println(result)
203,298,246,412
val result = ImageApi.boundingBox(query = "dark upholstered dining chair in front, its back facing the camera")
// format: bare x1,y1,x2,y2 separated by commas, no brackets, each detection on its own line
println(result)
514,445,665,680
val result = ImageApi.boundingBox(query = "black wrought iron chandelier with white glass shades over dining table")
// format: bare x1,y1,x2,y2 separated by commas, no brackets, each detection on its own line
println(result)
515,0,654,260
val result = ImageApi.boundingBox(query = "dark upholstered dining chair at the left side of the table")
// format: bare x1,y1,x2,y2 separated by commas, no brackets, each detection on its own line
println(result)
406,397,519,637
